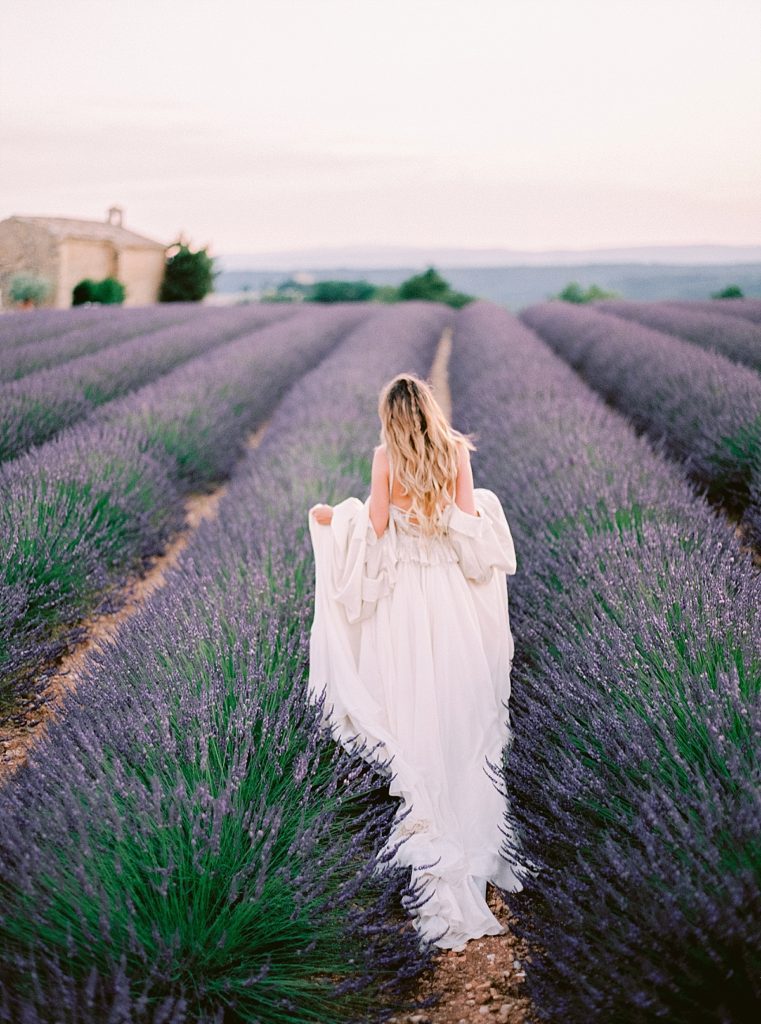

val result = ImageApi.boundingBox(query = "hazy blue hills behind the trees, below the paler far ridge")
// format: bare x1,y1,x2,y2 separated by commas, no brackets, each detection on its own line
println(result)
215,250,761,311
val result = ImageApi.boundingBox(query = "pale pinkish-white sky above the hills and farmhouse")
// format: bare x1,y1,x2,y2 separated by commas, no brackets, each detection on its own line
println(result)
0,0,761,254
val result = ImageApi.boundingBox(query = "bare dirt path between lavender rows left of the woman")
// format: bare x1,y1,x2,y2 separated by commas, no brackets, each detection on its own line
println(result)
0,423,267,785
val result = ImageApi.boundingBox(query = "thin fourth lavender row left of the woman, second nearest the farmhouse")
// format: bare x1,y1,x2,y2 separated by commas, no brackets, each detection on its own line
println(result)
0,303,209,381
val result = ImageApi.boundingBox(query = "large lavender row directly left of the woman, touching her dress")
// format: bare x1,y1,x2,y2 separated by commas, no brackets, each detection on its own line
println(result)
0,303,446,1024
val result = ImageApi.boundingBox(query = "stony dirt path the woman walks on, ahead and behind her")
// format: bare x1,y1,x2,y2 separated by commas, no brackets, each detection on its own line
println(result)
399,327,533,1024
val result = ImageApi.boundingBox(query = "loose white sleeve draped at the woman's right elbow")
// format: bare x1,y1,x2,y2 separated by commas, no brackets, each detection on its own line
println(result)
448,487,517,583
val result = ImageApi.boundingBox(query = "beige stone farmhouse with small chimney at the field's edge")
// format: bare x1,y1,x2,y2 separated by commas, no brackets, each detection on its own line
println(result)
0,206,167,309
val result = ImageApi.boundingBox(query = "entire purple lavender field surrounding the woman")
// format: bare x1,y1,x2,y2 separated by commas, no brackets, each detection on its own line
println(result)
0,300,761,1024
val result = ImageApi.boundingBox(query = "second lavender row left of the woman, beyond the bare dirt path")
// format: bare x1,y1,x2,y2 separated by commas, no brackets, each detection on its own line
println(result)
0,306,368,714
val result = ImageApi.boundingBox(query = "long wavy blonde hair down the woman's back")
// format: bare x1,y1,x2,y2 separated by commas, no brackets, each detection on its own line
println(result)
378,374,475,536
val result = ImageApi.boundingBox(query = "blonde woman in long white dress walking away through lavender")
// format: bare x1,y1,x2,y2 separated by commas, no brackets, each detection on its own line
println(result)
309,374,525,949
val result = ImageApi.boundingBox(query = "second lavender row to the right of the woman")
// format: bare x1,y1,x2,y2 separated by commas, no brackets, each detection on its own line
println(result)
521,302,761,544
